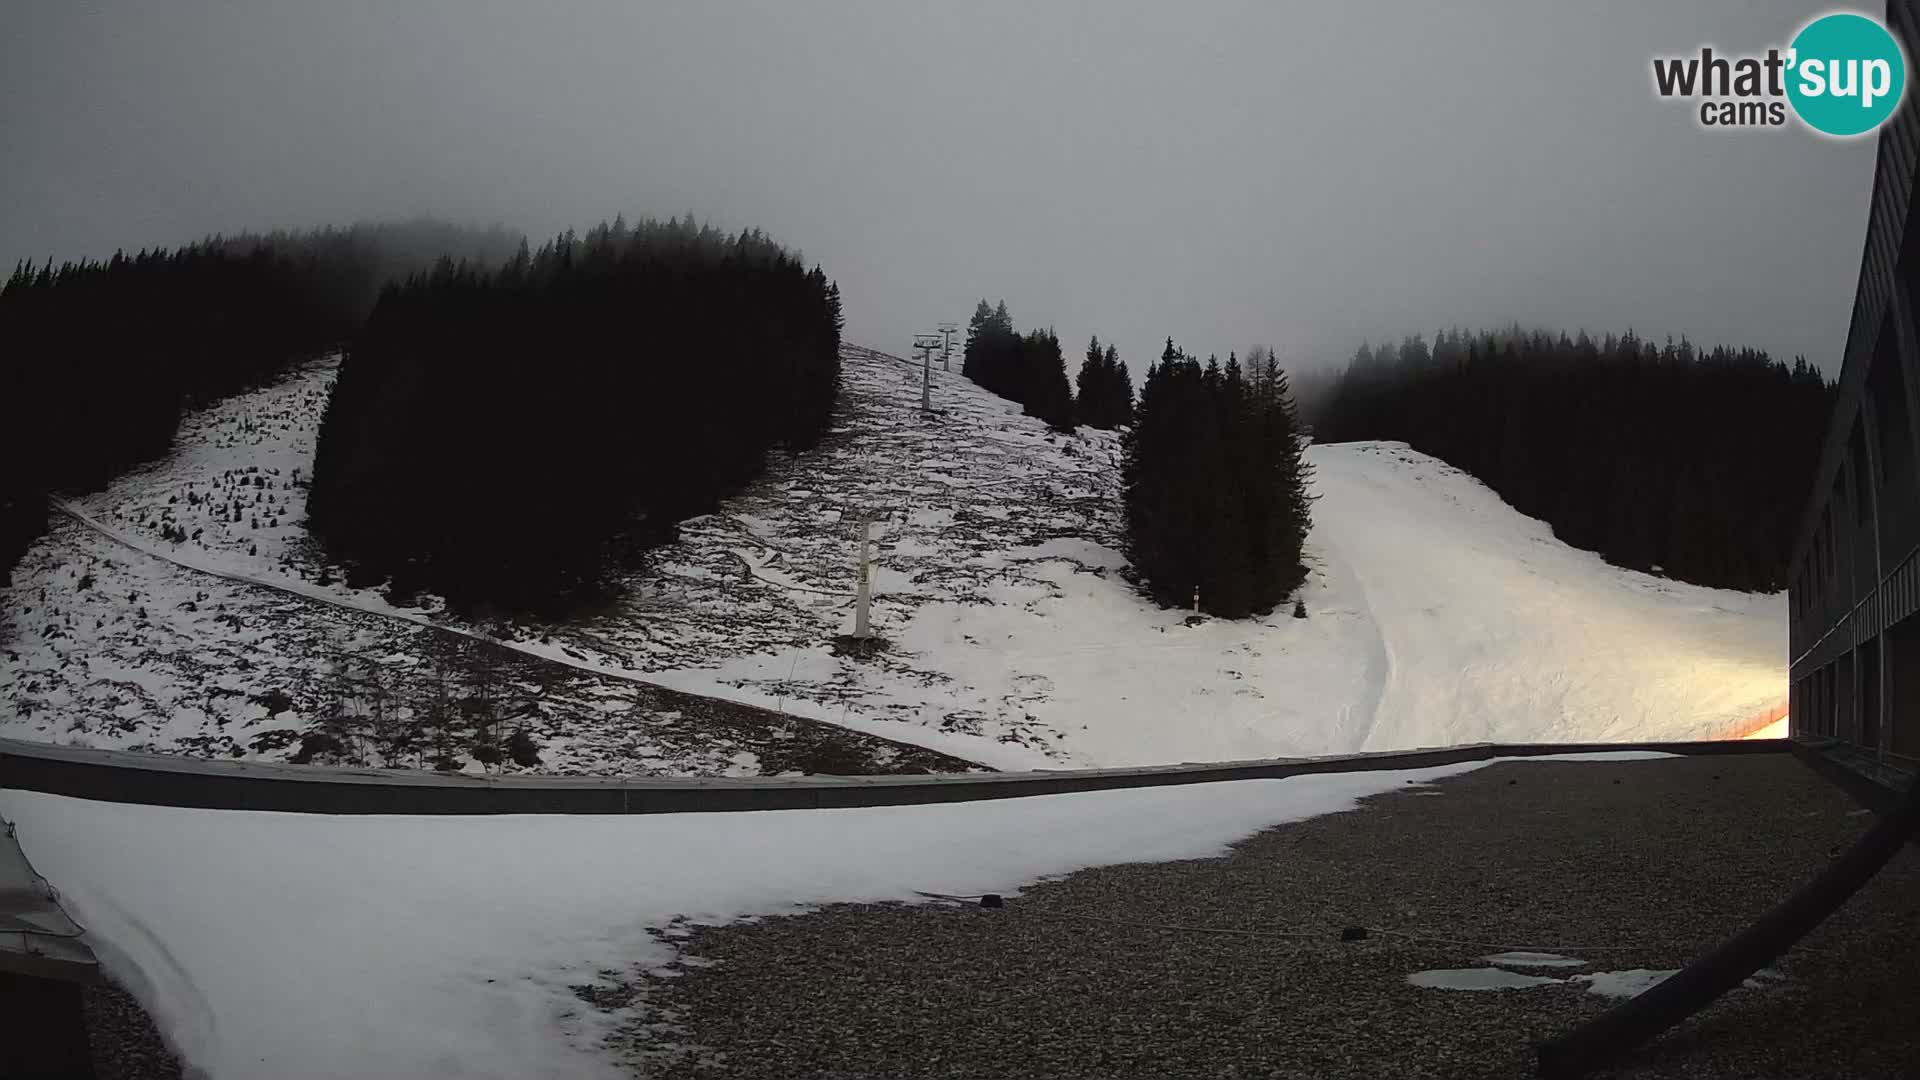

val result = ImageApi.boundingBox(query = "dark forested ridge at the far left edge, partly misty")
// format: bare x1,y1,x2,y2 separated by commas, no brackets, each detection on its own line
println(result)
0,221,520,582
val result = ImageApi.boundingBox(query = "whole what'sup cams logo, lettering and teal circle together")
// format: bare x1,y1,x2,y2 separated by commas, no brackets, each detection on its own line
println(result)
1653,12,1907,138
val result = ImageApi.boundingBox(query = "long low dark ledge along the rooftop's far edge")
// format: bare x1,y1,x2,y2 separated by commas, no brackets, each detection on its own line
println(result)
0,740,1791,815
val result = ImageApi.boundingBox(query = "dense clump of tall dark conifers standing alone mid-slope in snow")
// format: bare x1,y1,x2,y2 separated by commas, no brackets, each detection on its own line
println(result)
1123,340,1311,619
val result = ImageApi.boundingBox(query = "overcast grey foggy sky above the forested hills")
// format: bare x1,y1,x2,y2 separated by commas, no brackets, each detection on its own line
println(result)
0,0,1874,371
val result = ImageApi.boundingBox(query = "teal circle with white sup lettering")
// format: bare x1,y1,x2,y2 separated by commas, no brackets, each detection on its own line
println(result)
1788,12,1907,136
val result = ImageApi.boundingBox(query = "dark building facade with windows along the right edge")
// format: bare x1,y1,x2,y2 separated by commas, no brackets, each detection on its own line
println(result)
1788,0,1920,774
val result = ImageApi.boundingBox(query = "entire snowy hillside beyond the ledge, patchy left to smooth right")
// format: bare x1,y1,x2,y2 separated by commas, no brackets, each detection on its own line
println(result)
0,340,1786,773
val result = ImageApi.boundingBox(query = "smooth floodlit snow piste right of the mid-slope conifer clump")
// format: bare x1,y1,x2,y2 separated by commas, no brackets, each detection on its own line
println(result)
1309,444,1788,749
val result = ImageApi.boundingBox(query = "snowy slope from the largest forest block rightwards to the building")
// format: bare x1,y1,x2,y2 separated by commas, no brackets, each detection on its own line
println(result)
582,352,1786,767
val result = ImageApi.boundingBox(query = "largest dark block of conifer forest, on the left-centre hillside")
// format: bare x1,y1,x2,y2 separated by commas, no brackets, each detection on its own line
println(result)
309,217,841,611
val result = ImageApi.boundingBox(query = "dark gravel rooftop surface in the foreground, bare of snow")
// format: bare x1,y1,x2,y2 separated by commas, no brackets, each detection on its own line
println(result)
622,753,1920,1080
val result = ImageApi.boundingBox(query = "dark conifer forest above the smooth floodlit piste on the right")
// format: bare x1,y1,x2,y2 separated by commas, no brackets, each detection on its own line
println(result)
1313,329,1834,592
